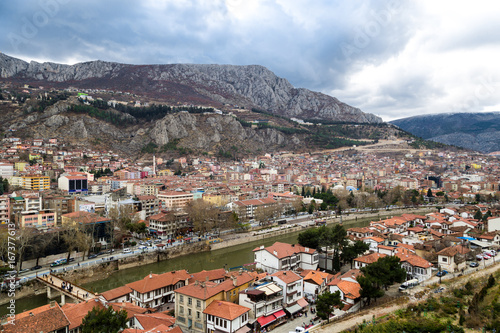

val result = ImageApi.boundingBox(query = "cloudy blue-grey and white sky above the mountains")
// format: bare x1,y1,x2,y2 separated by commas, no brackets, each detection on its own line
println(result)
0,0,500,121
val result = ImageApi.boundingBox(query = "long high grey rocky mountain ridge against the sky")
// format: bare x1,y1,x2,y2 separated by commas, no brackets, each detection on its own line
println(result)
0,53,382,123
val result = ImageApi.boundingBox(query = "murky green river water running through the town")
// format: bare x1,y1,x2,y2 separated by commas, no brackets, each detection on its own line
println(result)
0,219,371,317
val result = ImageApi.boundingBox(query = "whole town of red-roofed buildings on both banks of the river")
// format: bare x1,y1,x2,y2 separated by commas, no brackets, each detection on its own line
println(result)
0,125,500,333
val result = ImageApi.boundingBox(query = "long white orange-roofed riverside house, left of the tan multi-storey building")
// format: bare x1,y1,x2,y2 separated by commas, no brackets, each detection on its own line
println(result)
126,269,190,308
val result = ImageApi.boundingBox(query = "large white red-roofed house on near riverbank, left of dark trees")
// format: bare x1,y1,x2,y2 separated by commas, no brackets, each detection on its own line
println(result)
253,242,319,274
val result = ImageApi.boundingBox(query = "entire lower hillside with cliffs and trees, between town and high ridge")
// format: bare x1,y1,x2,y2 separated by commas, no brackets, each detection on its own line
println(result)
0,89,401,159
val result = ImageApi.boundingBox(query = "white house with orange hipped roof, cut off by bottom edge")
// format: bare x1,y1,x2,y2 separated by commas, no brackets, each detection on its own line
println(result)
203,301,251,333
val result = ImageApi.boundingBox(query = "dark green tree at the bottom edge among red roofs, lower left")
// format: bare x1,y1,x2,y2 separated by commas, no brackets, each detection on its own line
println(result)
80,306,127,333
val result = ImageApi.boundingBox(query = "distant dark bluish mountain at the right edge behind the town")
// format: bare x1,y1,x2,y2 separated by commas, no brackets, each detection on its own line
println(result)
390,112,500,153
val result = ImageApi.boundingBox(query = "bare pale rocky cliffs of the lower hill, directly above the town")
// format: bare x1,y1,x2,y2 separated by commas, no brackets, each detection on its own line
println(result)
1,97,303,156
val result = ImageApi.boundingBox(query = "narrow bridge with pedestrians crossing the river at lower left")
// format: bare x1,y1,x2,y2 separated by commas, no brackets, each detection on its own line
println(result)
36,273,97,305
